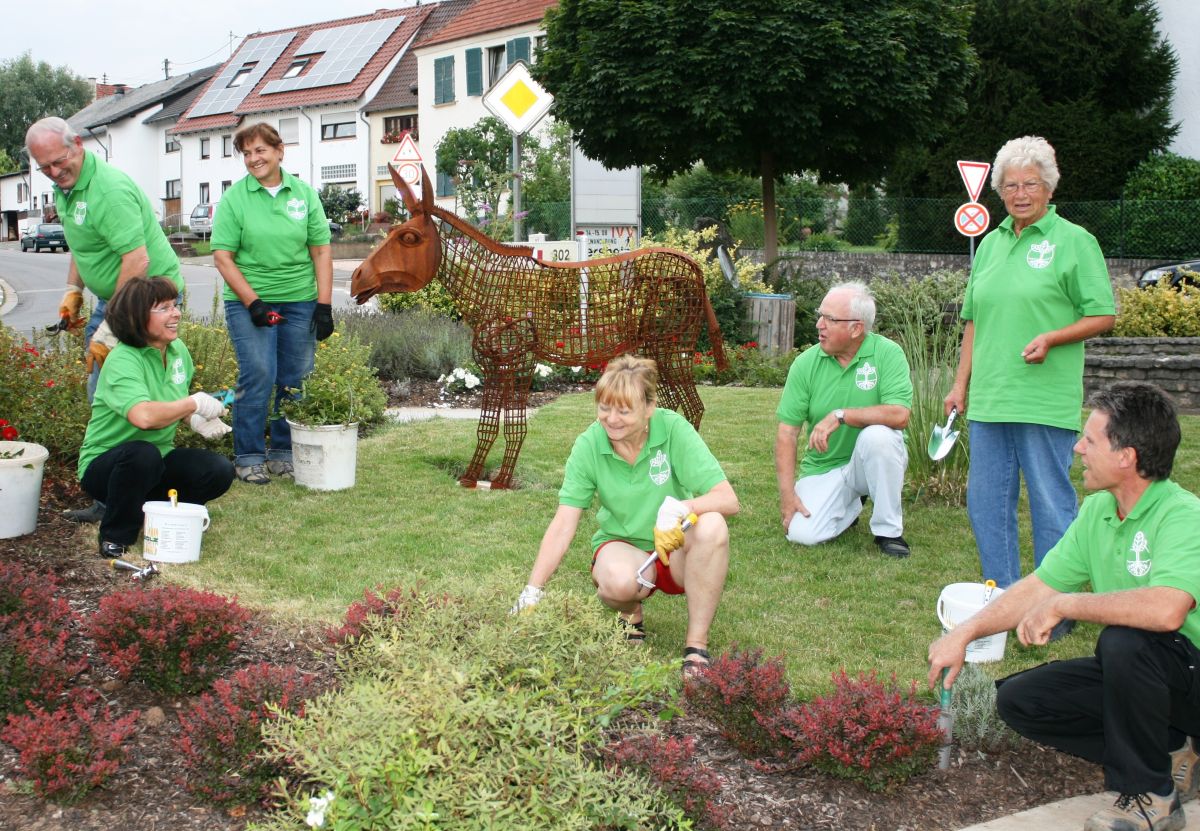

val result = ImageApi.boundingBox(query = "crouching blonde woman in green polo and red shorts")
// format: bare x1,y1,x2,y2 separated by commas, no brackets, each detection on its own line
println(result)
514,355,739,675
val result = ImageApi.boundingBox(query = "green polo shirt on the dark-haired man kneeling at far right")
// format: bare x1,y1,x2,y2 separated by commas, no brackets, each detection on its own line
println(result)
1034,479,1200,646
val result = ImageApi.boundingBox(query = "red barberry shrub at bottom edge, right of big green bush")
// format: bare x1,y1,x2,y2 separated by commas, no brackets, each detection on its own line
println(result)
606,734,732,829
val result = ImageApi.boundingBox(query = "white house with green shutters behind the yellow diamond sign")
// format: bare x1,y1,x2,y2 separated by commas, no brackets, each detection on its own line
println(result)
413,0,558,208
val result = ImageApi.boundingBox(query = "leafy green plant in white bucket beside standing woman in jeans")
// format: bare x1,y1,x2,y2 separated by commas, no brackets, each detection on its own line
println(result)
282,328,388,490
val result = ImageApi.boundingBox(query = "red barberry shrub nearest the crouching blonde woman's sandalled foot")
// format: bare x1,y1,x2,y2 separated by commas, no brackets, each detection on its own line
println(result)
683,645,791,757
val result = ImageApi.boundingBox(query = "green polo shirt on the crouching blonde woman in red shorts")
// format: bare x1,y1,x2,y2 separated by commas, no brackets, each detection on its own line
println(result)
558,407,726,551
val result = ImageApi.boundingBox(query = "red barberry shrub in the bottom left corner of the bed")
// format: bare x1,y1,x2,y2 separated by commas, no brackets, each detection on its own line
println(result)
0,688,140,805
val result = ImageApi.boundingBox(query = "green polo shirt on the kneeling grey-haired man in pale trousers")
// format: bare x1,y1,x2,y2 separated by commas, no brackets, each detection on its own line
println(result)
775,331,912,476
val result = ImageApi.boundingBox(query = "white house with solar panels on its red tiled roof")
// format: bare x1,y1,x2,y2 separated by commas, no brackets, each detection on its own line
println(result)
170,6,432,217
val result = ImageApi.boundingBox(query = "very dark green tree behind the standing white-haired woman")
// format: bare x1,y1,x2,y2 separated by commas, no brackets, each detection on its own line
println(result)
888,0,1178,201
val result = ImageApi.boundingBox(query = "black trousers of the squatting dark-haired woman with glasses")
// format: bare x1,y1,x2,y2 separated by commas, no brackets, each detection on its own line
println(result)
79,441,234,545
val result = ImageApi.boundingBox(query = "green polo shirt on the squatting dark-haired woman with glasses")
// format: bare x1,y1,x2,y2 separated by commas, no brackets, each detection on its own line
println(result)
78,340,193,477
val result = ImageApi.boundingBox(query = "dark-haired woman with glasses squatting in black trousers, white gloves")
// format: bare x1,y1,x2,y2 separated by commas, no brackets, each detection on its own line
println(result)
79,277,234,557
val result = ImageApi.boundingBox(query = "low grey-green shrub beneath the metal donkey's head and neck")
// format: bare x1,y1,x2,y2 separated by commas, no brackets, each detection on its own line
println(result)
338,306,470,381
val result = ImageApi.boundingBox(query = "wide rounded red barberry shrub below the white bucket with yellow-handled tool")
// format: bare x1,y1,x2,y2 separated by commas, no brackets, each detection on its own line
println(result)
86,586,251,695
